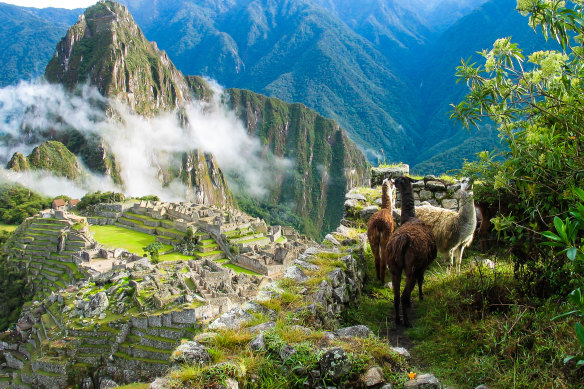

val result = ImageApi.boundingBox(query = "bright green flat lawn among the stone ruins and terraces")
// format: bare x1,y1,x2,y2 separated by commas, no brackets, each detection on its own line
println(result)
89,225,172,255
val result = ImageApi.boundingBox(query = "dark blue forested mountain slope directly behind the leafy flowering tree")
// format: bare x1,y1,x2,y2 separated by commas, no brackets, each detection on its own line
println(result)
413,0,557,173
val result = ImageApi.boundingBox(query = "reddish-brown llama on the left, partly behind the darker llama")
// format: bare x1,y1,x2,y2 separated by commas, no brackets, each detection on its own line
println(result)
367,179,395,280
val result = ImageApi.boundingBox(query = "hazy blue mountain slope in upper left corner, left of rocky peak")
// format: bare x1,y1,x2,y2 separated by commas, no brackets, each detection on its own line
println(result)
0,3,82,87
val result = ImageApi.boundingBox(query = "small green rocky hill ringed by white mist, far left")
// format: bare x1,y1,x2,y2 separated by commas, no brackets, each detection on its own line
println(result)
6,141,84,180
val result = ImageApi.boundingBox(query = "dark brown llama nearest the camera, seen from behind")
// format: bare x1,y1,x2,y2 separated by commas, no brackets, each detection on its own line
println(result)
380,177,438,327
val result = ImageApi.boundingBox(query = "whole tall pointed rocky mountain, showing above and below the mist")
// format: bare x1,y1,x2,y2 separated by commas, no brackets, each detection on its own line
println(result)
45,1,232,204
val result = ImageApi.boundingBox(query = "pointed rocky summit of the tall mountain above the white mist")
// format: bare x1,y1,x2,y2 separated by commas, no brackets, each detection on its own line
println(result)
45,0,189,116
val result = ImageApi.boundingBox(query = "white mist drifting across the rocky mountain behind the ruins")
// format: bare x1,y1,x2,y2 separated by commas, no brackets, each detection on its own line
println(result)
0,81,293,201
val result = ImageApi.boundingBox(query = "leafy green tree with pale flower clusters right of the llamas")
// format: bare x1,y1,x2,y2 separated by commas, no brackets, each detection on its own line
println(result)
452,0,584,294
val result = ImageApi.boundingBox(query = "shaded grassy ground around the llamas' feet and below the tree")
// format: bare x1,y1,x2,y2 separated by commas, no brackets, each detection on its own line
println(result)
344,246,584,389
